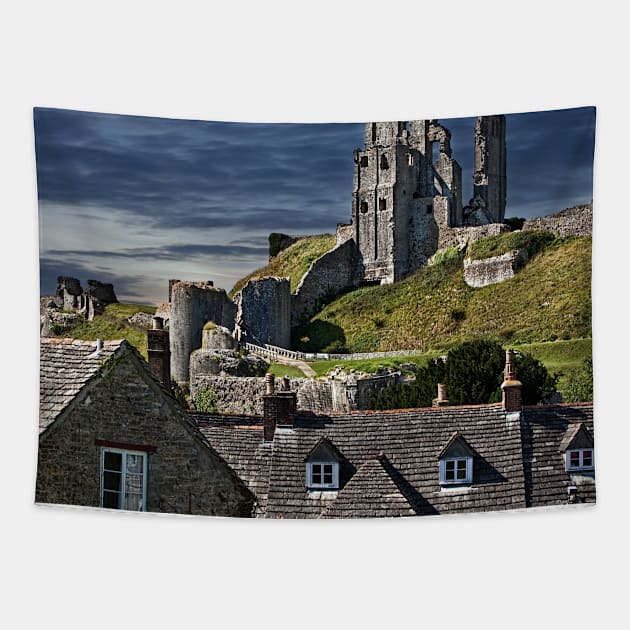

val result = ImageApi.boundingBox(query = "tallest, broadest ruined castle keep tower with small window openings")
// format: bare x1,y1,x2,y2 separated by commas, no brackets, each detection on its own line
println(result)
352,120,462,284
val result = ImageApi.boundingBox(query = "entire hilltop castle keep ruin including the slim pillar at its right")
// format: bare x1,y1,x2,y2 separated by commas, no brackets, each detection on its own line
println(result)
337,116,506,284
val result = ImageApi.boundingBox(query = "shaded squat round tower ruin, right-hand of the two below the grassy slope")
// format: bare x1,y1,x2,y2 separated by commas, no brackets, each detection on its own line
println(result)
234,278,291,348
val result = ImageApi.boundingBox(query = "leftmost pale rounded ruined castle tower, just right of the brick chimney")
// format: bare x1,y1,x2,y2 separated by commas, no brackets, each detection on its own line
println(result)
169,282,236,383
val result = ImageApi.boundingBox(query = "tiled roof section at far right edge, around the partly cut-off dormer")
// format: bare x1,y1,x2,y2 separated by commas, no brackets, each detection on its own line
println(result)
523,403,597,507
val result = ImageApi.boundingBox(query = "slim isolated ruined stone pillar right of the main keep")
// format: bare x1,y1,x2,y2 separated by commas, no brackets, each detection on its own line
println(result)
471,116,507,223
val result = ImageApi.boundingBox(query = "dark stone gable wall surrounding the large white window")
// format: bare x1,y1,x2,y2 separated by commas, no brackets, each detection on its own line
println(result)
36,350,253,516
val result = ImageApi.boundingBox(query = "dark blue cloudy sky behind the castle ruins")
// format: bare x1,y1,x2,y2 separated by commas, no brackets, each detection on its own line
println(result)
34,108,595,304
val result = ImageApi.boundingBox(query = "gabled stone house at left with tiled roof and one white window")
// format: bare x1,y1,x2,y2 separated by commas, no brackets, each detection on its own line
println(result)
36,338,255,517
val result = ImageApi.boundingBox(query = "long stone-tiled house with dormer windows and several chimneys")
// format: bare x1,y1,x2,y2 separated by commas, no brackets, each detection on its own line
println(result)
196,358,595,518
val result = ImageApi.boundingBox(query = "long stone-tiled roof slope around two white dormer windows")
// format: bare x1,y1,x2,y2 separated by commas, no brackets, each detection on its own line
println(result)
197,404,525,518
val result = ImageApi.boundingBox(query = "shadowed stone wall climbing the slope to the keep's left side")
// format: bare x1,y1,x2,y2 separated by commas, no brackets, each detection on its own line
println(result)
292,240,362,326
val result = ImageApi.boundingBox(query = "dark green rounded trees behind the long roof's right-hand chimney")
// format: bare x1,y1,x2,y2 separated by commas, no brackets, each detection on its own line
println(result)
370,339,558,409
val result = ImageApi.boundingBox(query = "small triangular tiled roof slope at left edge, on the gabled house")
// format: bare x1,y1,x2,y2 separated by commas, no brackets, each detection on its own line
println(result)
39,337,128,433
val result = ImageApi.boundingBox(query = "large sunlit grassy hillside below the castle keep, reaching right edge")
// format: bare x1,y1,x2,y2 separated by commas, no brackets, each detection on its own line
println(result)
293,237,591,352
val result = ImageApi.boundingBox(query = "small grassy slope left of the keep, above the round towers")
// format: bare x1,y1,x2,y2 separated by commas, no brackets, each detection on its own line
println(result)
229,234,335,297
